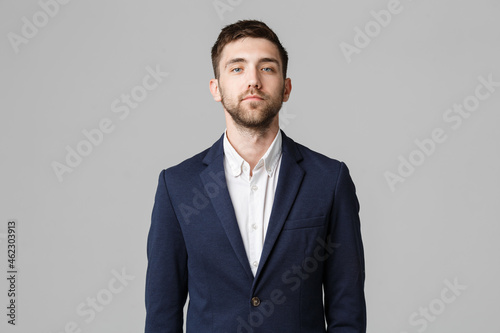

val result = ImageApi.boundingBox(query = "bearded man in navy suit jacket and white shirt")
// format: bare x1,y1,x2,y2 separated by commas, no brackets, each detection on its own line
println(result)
145,20,366,333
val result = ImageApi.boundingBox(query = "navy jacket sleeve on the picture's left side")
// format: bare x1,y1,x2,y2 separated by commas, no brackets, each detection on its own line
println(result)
145,170,188,333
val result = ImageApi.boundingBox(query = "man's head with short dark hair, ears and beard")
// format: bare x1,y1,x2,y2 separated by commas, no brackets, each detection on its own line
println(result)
210,21,292,131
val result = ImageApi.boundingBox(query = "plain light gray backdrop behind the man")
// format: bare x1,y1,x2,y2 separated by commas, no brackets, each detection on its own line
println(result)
0,0,500,333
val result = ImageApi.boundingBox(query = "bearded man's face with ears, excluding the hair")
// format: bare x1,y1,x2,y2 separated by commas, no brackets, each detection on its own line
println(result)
210,38,291,129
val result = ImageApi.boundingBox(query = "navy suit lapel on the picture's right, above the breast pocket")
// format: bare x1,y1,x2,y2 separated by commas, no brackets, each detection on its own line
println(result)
254,130,304,283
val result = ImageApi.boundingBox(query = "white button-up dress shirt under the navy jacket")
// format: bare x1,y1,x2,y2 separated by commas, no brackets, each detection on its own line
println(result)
224,128,282,276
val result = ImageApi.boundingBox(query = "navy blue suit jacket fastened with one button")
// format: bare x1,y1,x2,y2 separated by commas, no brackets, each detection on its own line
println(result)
145,131,366,333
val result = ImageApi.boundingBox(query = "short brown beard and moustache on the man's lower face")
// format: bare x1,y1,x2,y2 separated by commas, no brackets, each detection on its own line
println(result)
219,84,285,130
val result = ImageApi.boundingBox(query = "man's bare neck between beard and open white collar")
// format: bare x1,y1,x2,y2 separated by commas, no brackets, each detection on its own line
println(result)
226,117,279,172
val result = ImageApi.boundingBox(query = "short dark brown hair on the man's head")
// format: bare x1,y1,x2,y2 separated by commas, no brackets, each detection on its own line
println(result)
212,20,288,79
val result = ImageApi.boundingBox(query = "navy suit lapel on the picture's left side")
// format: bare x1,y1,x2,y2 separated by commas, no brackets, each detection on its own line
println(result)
200,134,254,280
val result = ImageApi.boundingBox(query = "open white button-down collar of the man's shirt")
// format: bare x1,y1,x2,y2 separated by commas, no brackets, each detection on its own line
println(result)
224,128,282,177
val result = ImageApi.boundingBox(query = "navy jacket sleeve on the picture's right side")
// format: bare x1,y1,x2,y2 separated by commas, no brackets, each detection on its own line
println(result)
323,162,366,333
